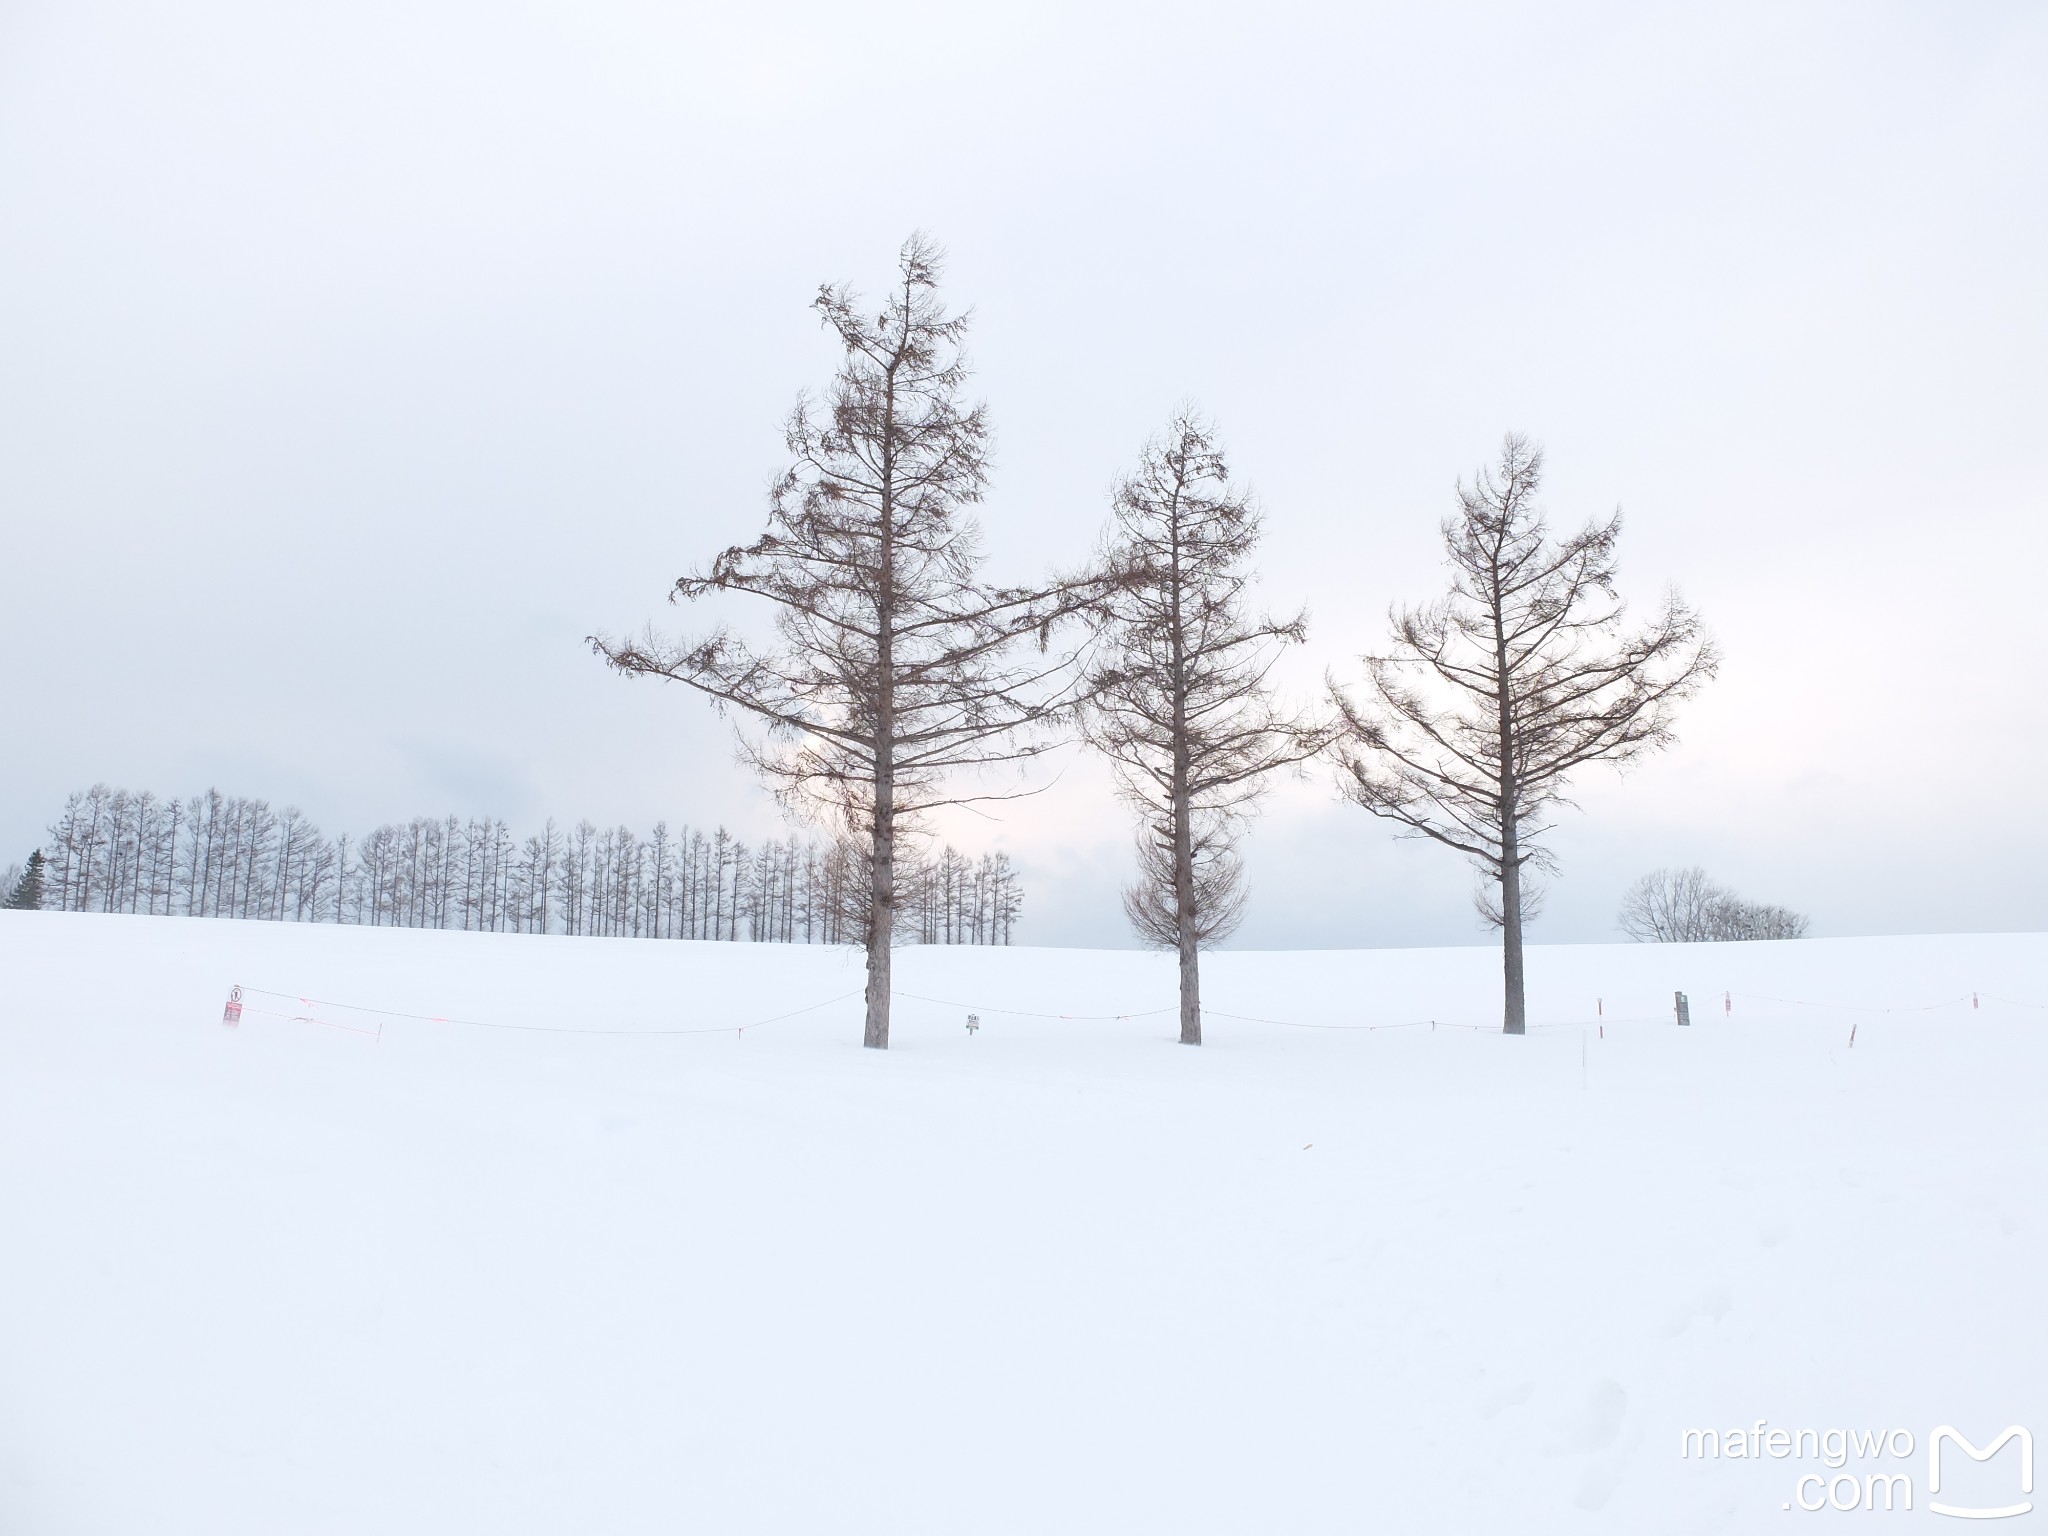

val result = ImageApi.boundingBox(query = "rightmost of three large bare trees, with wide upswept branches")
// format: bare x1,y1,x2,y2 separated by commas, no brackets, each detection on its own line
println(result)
1331,434,1718,1034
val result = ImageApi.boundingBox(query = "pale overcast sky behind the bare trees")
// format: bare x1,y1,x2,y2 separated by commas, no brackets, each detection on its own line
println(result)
0,0,2048,946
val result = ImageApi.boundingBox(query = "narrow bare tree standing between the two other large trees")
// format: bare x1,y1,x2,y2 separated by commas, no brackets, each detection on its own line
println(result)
1085,408,1331,1044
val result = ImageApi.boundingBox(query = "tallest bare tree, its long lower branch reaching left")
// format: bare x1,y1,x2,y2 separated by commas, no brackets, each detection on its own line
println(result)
592,236,1079,1049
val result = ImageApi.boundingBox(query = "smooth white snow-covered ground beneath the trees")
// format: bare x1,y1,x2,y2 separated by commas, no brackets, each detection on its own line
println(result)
0,913,2048,1536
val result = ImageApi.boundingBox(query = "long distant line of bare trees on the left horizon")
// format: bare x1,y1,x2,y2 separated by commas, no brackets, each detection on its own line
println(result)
6,784,1024,944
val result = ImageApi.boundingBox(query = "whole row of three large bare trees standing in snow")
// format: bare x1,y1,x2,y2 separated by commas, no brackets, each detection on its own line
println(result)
592,236,1716,1047
